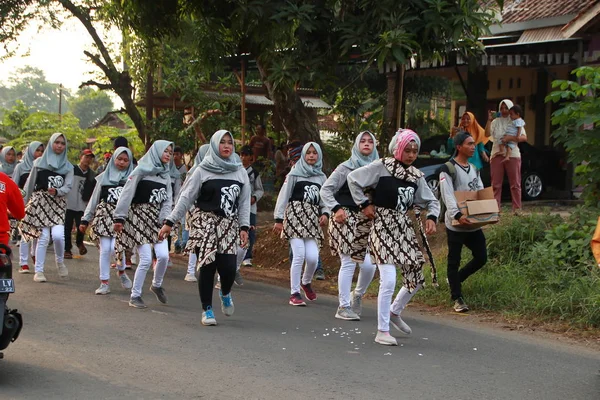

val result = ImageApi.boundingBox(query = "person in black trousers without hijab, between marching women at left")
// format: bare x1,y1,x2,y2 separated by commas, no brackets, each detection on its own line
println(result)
65,149,96,260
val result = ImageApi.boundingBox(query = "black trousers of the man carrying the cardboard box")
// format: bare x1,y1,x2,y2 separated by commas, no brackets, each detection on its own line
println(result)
446,228,487,300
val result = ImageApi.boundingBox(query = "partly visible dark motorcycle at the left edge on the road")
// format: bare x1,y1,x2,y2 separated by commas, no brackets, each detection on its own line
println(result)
0,244,23,358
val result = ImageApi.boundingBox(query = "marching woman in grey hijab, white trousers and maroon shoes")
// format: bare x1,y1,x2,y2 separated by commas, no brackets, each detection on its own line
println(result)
273,142,328,306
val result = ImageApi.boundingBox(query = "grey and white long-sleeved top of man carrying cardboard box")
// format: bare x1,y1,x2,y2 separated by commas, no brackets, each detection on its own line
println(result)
440,159,483,232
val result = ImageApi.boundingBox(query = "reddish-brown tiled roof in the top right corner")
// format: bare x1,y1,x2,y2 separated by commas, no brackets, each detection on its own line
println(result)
483,0,598,24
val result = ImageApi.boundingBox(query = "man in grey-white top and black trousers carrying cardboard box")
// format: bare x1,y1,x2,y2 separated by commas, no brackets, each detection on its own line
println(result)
440,132,487,312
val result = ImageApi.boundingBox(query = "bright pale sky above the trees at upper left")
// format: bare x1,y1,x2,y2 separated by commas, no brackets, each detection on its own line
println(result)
0,19,120,101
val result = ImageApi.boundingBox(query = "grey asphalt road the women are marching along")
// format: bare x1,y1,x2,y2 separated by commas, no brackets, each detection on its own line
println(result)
0,248,600,400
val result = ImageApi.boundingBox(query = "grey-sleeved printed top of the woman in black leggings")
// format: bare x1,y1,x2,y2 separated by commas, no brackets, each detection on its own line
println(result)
166,168,251,229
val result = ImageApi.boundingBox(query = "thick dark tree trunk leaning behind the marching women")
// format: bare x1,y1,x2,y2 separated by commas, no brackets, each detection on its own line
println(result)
256,60,322,145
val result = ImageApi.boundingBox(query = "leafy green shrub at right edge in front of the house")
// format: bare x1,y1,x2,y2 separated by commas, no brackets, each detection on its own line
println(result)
546,67,600,207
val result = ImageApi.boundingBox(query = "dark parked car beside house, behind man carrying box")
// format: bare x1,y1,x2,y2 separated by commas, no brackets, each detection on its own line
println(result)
415,142,565,200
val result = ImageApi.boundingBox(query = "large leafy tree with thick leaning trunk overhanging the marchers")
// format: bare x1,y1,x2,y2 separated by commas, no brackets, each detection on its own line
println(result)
123,0,502,142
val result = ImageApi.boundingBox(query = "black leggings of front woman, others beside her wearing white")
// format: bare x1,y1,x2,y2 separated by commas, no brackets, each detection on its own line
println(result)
198,254,236,311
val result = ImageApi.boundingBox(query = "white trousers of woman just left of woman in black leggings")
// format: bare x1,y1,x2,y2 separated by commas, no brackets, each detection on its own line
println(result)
131,240,169,298
